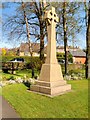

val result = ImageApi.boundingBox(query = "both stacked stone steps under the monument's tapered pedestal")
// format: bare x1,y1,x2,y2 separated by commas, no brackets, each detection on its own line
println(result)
31,80,71,96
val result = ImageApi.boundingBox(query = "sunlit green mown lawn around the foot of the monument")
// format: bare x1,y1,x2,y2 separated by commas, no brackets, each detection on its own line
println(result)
3,80,88,118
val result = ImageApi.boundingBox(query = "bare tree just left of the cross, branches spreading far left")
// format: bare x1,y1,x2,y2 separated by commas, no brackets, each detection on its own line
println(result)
2,0,46,60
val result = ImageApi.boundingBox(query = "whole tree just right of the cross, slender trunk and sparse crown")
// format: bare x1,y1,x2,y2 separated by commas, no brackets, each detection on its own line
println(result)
52,2,82,74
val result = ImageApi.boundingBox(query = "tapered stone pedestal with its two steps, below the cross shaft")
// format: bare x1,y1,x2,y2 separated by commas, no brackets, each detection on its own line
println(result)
30,64,71,96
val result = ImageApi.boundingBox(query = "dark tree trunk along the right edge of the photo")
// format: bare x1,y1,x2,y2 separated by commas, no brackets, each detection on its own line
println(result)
86,1,90,79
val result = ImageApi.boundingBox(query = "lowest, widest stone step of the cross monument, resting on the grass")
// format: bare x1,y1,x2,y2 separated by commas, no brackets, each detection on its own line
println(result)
30,84,71,96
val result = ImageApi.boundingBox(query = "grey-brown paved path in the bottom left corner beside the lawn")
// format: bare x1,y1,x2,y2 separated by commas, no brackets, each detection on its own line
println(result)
0,96,20,118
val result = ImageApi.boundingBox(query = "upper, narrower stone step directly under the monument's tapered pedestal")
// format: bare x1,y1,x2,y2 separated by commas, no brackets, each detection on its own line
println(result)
35,80,66,87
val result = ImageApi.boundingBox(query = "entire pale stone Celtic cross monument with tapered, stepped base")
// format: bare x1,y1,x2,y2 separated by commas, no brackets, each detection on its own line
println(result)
30,7,71,96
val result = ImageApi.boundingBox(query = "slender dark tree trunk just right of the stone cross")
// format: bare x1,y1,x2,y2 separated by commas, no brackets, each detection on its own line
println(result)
63,2,68,74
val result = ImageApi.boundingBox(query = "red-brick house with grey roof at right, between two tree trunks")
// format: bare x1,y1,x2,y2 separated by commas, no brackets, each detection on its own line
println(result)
69,50,86,64
